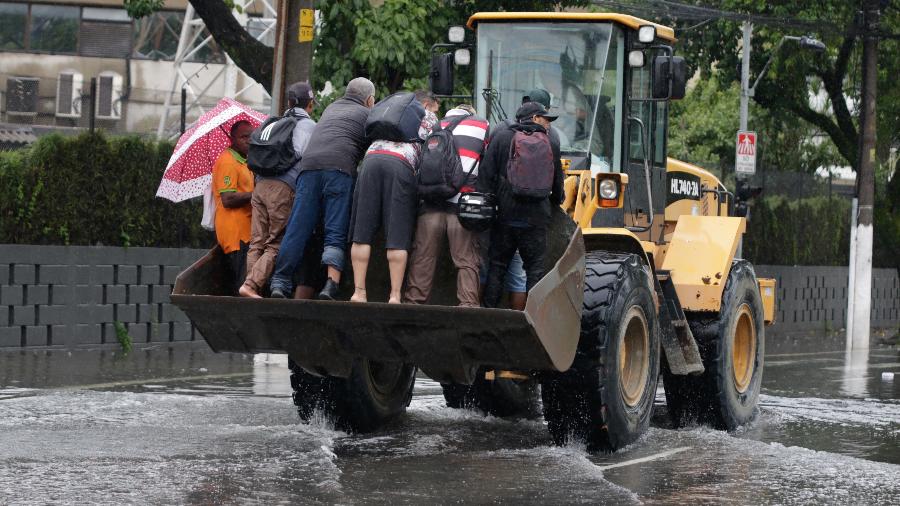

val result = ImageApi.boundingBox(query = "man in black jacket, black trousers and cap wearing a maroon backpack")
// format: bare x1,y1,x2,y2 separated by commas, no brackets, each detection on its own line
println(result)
476,102,564,307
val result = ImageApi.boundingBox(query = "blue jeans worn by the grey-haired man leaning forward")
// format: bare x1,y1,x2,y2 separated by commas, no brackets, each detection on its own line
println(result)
271,170,353,293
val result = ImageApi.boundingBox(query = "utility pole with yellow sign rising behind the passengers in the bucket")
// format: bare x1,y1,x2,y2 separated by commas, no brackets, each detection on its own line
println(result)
271,0,315,115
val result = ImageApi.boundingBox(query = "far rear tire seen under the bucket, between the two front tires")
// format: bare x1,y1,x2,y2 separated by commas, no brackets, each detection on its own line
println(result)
441,370,541,418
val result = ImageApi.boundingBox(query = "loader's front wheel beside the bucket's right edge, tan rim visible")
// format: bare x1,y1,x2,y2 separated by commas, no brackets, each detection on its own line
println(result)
541,251,659,451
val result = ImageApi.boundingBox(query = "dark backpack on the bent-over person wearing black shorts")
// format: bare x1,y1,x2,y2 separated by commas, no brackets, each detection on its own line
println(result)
366,91,425,142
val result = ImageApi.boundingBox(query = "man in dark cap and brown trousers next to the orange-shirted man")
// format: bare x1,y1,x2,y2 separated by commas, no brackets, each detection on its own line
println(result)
238,82,316,298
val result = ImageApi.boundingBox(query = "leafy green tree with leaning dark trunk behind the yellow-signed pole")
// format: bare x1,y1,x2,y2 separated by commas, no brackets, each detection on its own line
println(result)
125,0,589,96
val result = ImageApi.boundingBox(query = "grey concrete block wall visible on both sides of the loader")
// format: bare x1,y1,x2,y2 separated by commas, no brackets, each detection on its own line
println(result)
0,245,900,348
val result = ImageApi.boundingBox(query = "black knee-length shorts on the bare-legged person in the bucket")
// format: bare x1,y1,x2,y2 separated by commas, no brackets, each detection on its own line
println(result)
350,155,419,251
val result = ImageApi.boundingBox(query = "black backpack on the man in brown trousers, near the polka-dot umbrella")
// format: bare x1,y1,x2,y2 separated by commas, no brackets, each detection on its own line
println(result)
247,111,300,177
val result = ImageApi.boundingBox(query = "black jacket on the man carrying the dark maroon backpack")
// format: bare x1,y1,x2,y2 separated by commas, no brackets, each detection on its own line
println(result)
476,121,565,226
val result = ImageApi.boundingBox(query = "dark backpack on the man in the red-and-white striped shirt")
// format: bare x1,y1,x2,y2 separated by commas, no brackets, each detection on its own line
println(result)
417,115,475,202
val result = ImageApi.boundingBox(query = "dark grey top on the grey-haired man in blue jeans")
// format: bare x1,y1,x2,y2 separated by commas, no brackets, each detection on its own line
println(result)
300,96,369,178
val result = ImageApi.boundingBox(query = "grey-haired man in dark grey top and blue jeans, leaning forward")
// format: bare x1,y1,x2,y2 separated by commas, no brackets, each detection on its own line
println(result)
271,77,375,300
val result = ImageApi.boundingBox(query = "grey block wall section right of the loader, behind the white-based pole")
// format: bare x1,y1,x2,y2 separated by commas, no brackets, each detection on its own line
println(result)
756,265,900,332
